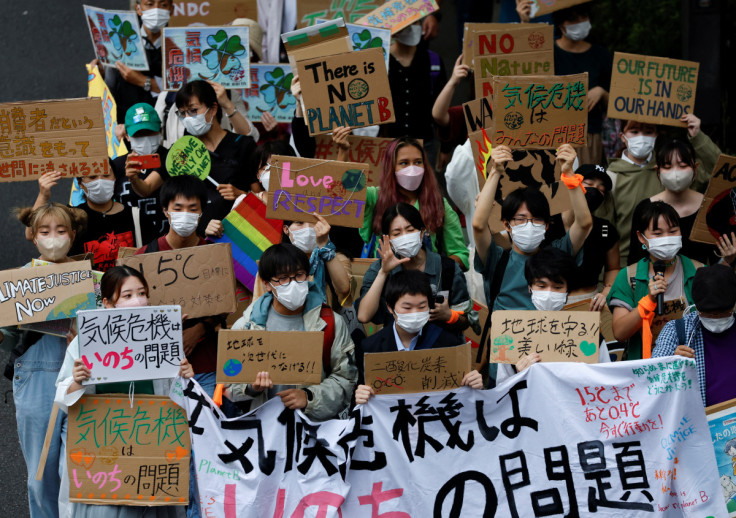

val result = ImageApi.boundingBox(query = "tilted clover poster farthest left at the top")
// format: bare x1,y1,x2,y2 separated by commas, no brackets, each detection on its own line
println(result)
84,5,148,70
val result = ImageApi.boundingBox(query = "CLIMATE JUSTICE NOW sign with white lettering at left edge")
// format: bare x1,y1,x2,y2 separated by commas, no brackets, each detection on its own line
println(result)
0,261,96,326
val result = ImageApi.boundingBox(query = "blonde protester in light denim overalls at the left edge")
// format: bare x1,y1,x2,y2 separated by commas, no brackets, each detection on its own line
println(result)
0,203,87,518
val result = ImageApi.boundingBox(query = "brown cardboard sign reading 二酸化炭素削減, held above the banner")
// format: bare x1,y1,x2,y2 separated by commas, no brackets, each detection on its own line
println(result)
365,344,472,394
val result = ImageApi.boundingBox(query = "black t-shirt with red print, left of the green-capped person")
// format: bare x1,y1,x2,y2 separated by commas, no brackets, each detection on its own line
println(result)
69,202,135,272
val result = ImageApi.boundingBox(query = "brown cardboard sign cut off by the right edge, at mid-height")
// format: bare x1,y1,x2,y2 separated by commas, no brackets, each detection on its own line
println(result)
690,155,736,244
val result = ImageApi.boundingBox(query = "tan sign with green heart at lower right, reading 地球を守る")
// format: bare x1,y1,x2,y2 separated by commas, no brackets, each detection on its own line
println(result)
490,310,601,364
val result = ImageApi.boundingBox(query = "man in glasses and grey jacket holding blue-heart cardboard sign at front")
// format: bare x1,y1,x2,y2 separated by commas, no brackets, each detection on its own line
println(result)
224,243,358,421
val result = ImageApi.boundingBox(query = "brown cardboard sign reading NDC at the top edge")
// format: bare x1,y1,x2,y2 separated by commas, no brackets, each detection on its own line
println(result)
169,0,258,27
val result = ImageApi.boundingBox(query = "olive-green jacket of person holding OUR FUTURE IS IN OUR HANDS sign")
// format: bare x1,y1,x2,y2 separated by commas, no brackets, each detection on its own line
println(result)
595,131,721,268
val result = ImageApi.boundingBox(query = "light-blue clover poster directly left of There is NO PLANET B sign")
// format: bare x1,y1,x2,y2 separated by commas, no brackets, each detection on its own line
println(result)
242,64,296,123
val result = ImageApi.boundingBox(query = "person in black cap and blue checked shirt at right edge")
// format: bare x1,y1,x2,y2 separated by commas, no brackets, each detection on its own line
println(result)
652,264,736,407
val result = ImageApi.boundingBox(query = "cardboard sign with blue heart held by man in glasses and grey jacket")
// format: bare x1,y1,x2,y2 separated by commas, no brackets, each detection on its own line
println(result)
217,330,324,385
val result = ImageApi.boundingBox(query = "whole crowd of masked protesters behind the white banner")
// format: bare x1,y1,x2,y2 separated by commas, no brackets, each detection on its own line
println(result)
0,0,736,518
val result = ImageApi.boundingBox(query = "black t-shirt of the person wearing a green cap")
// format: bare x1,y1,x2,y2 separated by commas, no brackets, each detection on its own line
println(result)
111,146,169,243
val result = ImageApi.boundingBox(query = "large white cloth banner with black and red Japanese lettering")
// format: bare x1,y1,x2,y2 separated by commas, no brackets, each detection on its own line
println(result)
171,357,727,518
